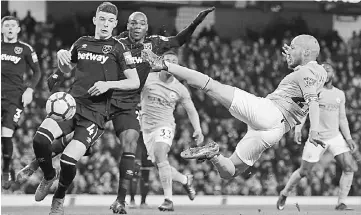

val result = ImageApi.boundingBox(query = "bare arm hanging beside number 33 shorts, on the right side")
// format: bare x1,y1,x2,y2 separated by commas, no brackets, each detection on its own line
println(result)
182,97,204,145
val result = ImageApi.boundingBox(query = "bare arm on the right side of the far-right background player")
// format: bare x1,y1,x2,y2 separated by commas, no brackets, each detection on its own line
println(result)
339,93,357,152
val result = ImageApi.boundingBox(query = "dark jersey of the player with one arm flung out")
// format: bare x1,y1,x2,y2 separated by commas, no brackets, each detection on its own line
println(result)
112,35,179,108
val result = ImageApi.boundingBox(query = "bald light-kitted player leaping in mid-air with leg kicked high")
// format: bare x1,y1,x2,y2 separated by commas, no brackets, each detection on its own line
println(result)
142,35,327,179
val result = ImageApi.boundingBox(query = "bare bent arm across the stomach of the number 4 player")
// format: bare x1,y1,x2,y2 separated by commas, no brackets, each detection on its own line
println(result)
88,68,140,96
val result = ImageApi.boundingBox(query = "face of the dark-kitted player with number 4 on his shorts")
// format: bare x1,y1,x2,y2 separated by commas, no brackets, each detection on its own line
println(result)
93,11,118,39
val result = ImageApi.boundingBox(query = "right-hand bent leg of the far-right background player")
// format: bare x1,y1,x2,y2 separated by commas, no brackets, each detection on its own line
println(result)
335,151,357,210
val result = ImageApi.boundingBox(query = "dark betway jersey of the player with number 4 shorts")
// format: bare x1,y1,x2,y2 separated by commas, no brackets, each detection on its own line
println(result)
69,36,135,115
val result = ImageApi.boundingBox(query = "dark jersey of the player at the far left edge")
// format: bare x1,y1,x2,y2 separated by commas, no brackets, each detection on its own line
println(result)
1,41,38,93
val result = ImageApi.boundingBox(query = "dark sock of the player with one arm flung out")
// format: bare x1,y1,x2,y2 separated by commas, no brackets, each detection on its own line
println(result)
117,152,135,201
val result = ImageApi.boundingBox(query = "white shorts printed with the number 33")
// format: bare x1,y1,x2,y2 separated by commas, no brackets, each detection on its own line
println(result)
143,126,174,162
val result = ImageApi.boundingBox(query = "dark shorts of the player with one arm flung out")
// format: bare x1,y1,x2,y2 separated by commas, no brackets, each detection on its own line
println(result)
109,103,140,136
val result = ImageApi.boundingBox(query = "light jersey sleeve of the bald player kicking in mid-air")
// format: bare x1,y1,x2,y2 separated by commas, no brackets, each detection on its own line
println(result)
296,69,318,103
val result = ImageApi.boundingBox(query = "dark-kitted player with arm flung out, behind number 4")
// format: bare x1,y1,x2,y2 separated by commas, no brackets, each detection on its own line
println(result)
110,8,214,214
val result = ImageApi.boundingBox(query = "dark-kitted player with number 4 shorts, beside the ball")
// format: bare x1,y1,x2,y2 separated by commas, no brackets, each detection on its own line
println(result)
33,2,139,215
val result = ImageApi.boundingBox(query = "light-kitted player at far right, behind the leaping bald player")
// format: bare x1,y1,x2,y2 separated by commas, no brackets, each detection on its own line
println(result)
277,62,357,210
